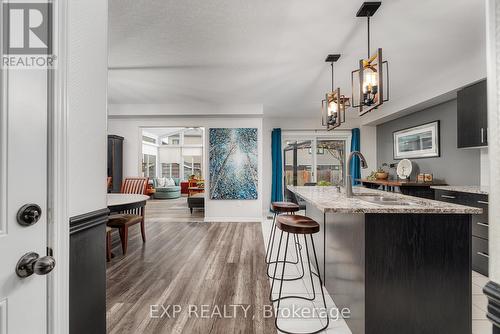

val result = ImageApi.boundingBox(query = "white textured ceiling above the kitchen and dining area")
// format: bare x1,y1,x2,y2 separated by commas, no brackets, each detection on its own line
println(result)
109,0,486,120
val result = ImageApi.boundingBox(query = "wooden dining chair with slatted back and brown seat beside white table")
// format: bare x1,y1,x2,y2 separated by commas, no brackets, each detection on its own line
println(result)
107,177,148,255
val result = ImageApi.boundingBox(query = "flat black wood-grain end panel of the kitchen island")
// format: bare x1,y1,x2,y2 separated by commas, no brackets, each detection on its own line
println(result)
365,214,472,334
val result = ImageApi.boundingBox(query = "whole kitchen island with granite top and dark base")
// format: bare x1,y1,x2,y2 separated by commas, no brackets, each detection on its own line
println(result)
288,186,482,334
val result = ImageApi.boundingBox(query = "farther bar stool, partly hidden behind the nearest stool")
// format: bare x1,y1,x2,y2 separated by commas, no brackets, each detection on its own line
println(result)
266,202,304,281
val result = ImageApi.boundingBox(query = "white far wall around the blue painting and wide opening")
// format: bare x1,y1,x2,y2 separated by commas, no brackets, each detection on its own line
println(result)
108,114,263,221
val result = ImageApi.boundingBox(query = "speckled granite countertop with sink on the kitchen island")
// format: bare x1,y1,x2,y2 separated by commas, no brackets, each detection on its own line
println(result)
287,186,482,214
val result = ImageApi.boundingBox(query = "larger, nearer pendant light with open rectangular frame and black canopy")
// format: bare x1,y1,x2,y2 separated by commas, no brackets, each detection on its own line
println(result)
351,2,389,116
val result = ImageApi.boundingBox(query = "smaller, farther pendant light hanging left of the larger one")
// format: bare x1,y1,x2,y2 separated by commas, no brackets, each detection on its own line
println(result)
321,54,351,131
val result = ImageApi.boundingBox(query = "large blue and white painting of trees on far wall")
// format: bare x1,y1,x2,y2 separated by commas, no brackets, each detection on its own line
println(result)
209,128,258,200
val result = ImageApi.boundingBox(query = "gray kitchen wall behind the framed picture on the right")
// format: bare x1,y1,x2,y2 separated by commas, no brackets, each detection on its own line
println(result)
378,100,480,185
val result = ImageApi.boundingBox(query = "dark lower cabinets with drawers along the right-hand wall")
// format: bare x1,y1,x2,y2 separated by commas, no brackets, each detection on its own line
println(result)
435,190,489,276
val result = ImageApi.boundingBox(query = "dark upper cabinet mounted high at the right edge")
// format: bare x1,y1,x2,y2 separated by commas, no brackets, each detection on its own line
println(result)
457,80,488,148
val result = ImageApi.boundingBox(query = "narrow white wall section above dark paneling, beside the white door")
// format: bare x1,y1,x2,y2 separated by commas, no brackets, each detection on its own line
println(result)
67,0,108,217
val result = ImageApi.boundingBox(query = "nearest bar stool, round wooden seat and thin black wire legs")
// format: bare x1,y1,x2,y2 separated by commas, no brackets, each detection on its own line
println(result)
269,215,330,334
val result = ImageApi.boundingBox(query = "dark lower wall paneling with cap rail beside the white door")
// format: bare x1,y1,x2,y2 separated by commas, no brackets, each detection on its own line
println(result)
69,209,109,334
